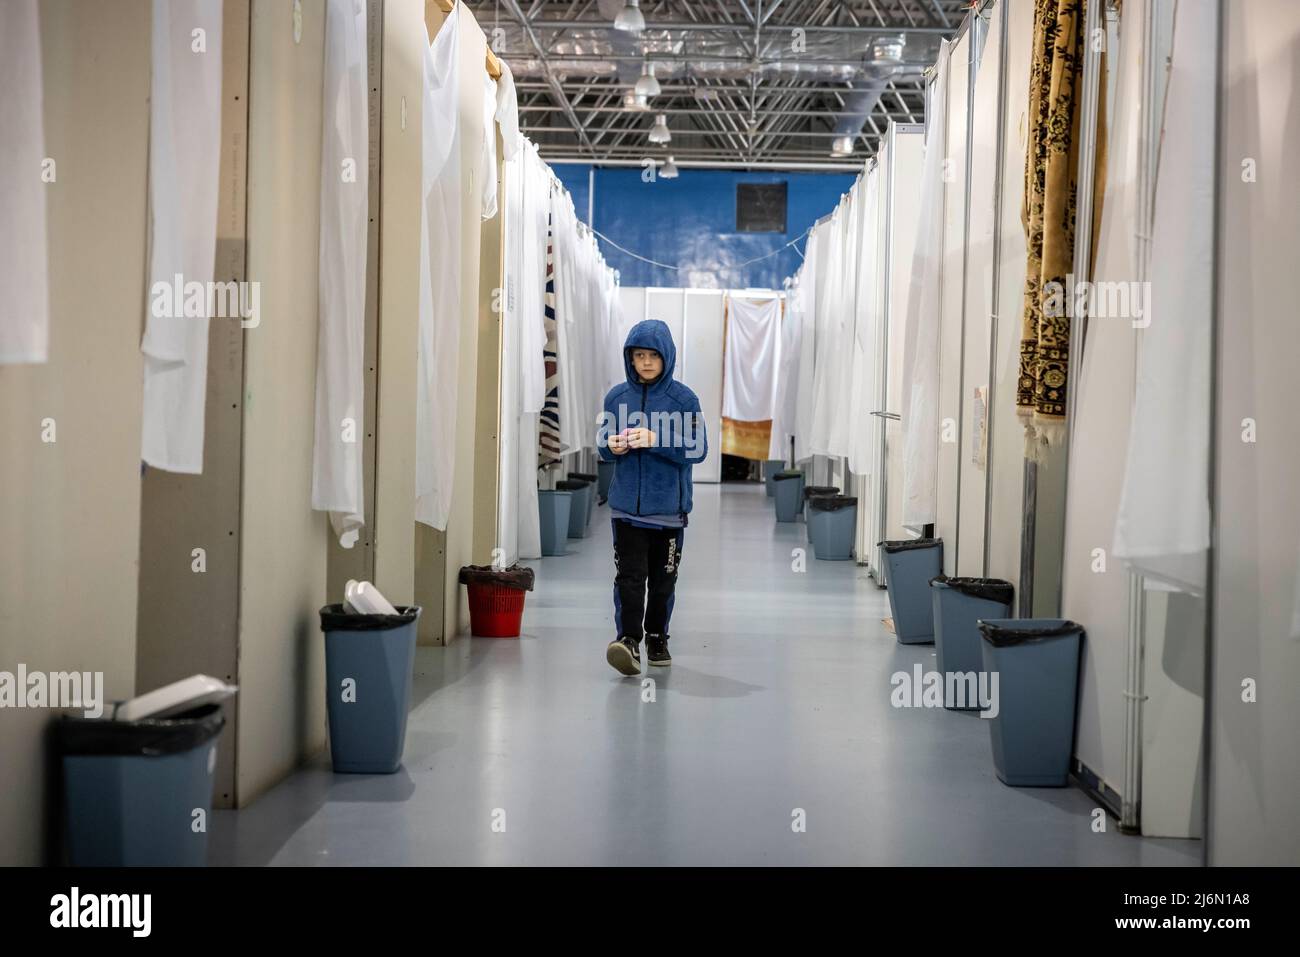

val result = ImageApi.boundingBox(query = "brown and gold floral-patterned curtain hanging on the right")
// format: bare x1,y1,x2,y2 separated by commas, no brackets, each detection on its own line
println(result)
1015,0,1106,458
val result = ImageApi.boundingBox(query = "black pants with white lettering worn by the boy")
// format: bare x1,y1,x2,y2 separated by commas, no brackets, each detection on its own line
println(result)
614,519,686,641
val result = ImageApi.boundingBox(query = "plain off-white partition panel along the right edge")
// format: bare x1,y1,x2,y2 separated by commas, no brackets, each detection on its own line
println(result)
1206,0,1300,865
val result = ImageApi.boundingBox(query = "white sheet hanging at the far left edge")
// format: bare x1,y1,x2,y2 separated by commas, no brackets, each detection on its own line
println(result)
0,0,47,365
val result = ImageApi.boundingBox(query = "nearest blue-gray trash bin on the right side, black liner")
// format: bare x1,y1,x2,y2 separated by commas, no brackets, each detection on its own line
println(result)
979,618,1084,788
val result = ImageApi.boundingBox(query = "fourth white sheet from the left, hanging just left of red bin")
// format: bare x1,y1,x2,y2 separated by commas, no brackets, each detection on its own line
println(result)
415,4,465,529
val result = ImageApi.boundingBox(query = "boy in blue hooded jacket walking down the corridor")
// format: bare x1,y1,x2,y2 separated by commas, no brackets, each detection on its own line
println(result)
597,319,709,675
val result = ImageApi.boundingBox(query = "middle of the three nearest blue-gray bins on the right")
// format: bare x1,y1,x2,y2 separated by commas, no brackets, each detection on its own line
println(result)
930,575,1015,711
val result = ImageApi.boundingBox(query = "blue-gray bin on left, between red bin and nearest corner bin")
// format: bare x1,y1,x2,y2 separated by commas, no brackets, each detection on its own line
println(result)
320,605,420,774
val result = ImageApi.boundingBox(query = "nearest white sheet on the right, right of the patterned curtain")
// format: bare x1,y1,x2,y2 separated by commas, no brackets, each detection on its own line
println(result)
1097,4,1218,593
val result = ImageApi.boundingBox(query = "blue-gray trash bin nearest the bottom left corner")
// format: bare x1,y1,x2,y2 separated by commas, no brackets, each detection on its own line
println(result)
56,705,225,867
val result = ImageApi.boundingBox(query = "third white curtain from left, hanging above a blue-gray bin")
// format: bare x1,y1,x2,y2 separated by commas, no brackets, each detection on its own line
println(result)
312,0,369,549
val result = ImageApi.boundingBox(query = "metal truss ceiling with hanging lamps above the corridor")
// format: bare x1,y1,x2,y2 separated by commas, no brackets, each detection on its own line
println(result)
463,0,970,169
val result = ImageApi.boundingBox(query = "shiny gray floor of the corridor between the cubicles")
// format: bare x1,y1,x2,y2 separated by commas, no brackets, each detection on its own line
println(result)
211,485,1200,865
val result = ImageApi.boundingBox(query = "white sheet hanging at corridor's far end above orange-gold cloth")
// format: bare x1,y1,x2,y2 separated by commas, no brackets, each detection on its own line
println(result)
723,294,781,423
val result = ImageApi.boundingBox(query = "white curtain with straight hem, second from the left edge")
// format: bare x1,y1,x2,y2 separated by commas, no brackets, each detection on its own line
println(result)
140,0,226,475
